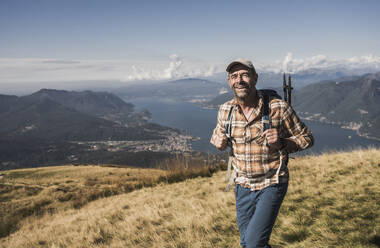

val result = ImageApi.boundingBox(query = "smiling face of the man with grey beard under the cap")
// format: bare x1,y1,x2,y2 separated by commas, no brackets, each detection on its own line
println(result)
228,64,257,100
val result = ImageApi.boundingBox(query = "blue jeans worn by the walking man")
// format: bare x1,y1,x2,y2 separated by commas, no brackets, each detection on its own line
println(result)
234,183,288,248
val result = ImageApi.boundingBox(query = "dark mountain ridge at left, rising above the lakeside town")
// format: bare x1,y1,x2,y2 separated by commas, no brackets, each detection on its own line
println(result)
0,89,169,141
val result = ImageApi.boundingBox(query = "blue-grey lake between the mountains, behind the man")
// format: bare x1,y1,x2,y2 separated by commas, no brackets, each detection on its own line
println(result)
129,98,380,154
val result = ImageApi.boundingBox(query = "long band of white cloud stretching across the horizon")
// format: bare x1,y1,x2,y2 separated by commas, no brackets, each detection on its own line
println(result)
0,52,380,85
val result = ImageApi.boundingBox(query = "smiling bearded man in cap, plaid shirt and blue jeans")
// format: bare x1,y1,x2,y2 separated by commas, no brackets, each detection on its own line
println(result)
211,59,314,248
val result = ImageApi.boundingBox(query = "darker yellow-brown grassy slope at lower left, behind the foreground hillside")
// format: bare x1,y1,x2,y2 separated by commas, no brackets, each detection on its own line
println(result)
0,166,216,238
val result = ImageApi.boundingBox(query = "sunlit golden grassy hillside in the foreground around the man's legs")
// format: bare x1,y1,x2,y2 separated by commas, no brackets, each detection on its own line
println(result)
0,149,380,247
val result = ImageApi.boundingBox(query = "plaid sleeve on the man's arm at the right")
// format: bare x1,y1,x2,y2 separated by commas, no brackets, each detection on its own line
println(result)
282,104,314,153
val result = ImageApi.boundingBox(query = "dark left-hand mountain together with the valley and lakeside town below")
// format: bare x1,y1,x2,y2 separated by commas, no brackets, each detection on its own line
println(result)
0,89,184,169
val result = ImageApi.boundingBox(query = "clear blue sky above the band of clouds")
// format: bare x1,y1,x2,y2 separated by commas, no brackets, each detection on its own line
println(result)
0,0,380,83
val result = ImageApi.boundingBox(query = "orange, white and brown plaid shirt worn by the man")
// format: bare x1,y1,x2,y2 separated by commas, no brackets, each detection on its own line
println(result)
210,95,314,190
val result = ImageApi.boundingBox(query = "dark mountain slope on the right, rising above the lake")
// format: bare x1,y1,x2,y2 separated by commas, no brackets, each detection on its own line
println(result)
293,72,380,139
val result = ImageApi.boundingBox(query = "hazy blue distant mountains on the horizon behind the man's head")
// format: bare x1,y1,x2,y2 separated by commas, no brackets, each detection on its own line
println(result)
113,68,374,103
